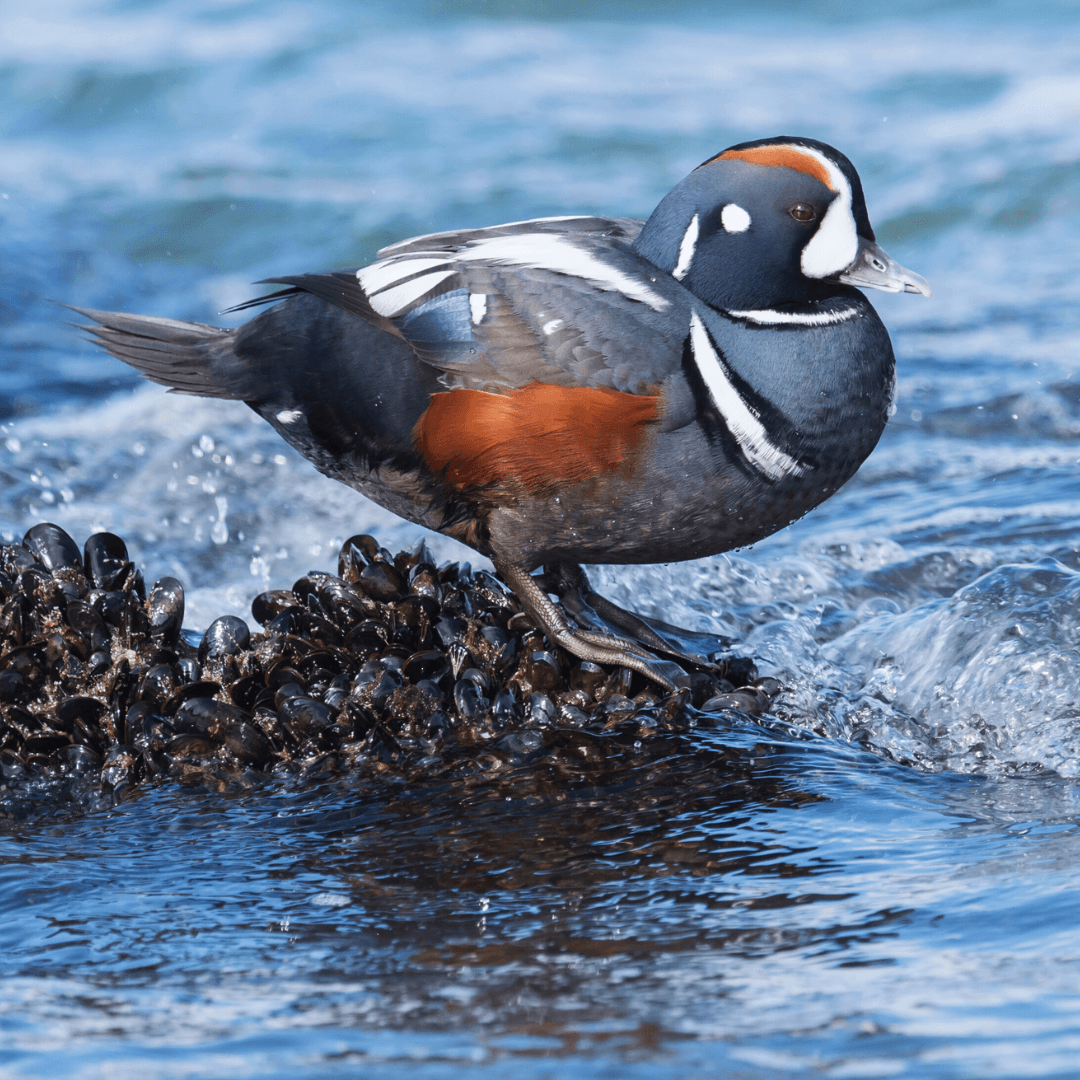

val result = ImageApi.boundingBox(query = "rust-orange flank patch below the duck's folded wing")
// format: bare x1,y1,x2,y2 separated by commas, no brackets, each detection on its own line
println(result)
414,382,659,494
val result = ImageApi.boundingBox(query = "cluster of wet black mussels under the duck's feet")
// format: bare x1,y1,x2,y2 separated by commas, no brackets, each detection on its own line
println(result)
0,524,774,812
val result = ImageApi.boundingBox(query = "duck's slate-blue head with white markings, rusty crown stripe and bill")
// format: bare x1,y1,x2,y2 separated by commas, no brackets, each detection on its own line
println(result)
634,136,930,311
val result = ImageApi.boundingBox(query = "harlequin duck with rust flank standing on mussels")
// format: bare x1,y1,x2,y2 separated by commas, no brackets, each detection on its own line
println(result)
82,136,930,687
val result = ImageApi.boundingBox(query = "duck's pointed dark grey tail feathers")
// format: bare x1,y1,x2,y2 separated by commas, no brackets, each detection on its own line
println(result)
71,308,257,401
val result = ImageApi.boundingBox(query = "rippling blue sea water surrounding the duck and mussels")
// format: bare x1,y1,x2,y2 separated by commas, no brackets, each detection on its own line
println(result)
0,0,1080,1080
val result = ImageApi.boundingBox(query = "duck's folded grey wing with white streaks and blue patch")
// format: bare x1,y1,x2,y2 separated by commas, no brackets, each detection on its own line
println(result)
245,217,689,394
